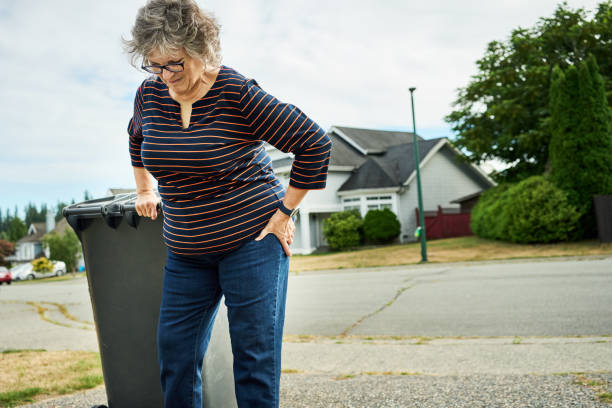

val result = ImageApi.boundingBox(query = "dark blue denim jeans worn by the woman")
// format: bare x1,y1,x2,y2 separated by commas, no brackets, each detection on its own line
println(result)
157,234,289,408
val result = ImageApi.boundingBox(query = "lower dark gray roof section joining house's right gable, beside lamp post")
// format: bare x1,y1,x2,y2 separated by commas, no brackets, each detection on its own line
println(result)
338,138,443,191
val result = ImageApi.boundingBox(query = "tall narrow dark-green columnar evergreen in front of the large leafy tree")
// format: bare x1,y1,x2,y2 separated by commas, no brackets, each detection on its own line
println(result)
549,55,612,238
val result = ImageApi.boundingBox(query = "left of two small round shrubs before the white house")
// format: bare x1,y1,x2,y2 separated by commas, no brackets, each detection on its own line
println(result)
323,210,363,251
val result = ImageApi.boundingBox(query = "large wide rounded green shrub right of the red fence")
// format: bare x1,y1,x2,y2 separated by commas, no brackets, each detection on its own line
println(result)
470,176,580,243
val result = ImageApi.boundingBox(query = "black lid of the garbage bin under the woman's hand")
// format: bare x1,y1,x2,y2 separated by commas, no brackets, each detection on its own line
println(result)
62,191,163,239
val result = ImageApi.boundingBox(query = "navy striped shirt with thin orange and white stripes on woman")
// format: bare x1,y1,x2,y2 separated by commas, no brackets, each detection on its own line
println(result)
128,66,331,255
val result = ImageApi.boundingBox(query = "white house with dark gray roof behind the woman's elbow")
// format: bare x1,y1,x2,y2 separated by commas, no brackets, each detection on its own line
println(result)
268,126,495,254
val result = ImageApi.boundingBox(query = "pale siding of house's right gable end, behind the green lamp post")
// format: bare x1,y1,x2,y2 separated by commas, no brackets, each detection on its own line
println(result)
400,146,486,242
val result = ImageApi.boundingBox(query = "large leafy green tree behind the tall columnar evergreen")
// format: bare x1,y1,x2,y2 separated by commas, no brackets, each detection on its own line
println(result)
446,0,612,181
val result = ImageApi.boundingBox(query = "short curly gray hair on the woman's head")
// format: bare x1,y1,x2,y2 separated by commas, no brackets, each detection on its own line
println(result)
123,0,221,68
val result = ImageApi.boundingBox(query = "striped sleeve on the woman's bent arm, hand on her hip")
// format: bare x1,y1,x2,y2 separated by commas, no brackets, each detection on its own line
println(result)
240,79,332,190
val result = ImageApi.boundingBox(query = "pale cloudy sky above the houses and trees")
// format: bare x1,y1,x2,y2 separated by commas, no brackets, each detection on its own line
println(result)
0,0,598,216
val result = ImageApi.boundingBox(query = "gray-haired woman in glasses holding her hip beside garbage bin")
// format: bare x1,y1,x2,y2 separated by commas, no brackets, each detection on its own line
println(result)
120,0,331,408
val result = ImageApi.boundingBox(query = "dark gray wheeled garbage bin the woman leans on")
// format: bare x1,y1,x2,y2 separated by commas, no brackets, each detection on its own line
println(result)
63,193,237,408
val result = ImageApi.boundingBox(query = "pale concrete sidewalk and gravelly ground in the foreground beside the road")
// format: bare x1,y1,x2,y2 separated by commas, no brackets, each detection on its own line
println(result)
21,337,612,408
